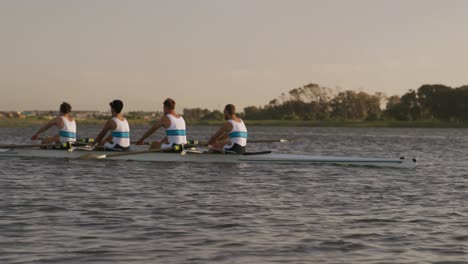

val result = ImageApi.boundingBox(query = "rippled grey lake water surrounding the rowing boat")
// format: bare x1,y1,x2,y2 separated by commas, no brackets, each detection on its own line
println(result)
0,126,468,263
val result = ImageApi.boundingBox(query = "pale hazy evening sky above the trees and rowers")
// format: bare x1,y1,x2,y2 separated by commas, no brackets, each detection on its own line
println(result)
0,0,468,111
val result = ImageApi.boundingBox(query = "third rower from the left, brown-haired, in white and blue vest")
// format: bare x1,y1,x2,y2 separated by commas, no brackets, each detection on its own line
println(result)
136,98,187,149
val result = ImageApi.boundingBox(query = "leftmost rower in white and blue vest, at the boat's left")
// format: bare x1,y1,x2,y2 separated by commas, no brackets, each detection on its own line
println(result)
31,102,76,144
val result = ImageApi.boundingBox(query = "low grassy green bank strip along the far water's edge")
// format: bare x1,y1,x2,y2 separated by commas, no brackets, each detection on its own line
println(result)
0,118,468,128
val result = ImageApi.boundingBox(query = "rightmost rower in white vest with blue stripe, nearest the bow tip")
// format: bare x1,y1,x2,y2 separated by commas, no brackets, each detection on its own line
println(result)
207,104,247,154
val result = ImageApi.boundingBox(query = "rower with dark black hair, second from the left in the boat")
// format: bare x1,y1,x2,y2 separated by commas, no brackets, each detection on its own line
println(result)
94,100,130,151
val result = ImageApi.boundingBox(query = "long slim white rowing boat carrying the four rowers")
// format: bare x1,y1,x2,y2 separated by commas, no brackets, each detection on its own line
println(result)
0,148,416,168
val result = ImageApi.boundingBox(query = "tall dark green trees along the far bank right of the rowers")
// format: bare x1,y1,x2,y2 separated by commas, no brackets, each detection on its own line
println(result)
244,84,468,122
